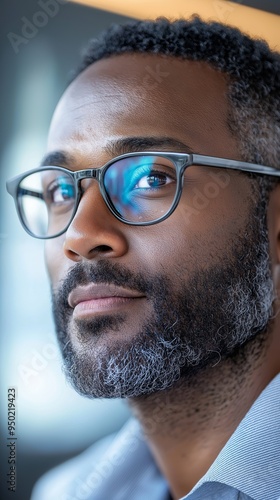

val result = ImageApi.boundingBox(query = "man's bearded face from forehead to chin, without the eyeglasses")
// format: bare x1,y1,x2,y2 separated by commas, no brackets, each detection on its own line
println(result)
46,55,272,397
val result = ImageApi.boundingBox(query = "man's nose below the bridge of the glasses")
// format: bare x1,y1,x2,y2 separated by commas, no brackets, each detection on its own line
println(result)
64,181,128,262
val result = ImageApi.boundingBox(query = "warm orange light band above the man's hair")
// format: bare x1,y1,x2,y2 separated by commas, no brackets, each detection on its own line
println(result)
71,0,280,51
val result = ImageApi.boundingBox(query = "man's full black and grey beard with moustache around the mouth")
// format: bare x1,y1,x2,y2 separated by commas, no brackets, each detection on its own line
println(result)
53,199,274,398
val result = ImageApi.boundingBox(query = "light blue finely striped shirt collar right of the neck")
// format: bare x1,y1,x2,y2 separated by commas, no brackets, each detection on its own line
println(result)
184,374,280,500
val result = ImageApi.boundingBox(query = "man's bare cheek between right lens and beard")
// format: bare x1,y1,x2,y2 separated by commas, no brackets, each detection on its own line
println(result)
131,182,251,279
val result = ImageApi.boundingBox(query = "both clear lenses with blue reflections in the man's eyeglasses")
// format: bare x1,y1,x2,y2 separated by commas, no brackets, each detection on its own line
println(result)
18,155,177,237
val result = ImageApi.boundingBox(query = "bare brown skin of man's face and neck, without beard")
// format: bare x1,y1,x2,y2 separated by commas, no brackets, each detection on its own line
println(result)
43,54,280,499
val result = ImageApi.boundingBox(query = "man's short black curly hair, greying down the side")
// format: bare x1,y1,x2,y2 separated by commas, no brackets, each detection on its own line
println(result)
71,16,280,192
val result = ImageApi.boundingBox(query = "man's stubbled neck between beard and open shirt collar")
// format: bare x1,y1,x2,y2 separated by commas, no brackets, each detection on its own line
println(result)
130,330,276,499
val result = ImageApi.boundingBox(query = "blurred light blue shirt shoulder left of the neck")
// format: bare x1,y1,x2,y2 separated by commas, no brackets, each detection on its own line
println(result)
31,418,167,500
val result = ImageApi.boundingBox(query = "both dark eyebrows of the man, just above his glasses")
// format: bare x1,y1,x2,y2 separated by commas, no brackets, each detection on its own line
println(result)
40,136,194,169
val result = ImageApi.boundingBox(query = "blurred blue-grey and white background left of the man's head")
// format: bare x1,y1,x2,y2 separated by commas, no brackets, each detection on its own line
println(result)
0,0,280,500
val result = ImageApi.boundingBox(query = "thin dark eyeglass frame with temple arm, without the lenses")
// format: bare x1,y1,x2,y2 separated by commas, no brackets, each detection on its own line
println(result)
6,151,280,240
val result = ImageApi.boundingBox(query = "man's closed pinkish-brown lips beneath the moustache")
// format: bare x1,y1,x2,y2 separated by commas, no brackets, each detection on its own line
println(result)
68,283,144,309
